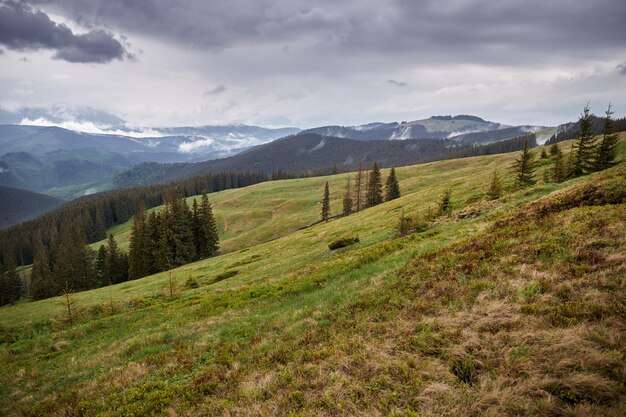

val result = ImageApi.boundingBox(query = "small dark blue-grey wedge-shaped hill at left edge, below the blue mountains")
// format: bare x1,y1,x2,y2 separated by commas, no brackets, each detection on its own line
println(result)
0,186,64,229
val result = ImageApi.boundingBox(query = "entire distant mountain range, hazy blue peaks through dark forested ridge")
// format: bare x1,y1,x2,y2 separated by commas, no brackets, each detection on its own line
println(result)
0,108,555,199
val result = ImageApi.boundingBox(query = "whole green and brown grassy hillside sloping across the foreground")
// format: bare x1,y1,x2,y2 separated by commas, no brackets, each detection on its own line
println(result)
0,136,626,416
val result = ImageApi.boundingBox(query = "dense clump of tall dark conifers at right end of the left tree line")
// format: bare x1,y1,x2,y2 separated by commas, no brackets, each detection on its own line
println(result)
128,193,219,279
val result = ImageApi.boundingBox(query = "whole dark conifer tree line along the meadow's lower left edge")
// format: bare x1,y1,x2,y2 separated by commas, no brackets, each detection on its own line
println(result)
0,193,219,304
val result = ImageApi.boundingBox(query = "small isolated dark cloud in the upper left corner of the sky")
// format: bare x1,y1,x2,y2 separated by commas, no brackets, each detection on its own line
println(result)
0,1,130,63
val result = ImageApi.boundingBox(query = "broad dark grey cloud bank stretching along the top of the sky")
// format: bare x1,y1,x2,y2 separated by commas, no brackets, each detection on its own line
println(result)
31,0,626,64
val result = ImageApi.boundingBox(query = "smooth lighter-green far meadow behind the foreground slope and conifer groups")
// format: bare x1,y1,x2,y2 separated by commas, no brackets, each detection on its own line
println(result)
91,136,548,252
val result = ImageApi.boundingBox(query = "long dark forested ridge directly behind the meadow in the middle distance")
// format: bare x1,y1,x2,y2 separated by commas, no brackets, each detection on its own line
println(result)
115,133,523,187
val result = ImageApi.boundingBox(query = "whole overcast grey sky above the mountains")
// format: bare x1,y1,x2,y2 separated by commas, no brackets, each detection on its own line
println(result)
0,0,626,128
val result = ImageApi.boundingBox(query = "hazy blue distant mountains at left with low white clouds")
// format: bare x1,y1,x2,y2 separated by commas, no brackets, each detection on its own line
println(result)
0,125,299,198
